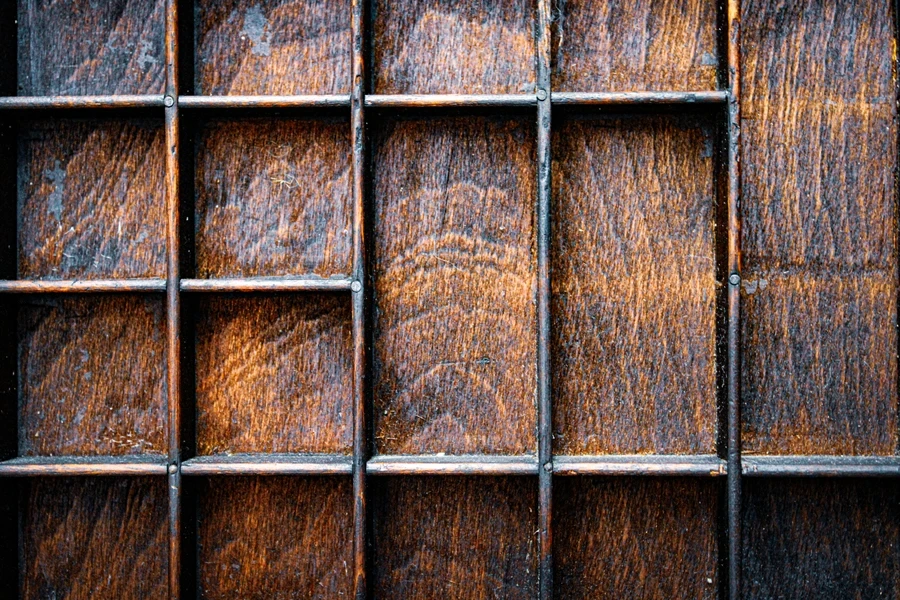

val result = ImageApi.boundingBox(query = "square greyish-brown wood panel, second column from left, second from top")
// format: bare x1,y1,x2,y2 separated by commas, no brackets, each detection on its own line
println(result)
196,120,352,277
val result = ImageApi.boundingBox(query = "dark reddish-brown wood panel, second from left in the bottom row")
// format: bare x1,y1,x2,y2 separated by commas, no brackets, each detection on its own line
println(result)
197,477,353,600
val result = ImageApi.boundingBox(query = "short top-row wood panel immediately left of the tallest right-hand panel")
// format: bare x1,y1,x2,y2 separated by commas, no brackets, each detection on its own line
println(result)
551,0,718,92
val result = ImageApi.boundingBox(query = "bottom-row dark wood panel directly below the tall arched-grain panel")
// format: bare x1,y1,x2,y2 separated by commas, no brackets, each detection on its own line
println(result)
371,477,537,600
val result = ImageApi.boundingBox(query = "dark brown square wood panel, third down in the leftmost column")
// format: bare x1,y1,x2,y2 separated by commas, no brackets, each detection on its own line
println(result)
19,295,167,456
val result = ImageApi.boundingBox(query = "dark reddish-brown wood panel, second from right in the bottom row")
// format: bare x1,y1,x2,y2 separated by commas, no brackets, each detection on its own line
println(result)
553,477,718,600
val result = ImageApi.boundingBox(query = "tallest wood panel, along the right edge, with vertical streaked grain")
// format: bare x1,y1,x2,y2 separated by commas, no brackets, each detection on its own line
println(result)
741,0,898,454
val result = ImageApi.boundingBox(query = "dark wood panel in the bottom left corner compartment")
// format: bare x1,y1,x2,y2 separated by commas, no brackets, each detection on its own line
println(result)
20,477,168,600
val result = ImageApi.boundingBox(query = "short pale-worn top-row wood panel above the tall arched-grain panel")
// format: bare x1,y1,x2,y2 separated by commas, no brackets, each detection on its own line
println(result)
372,0,535,94
